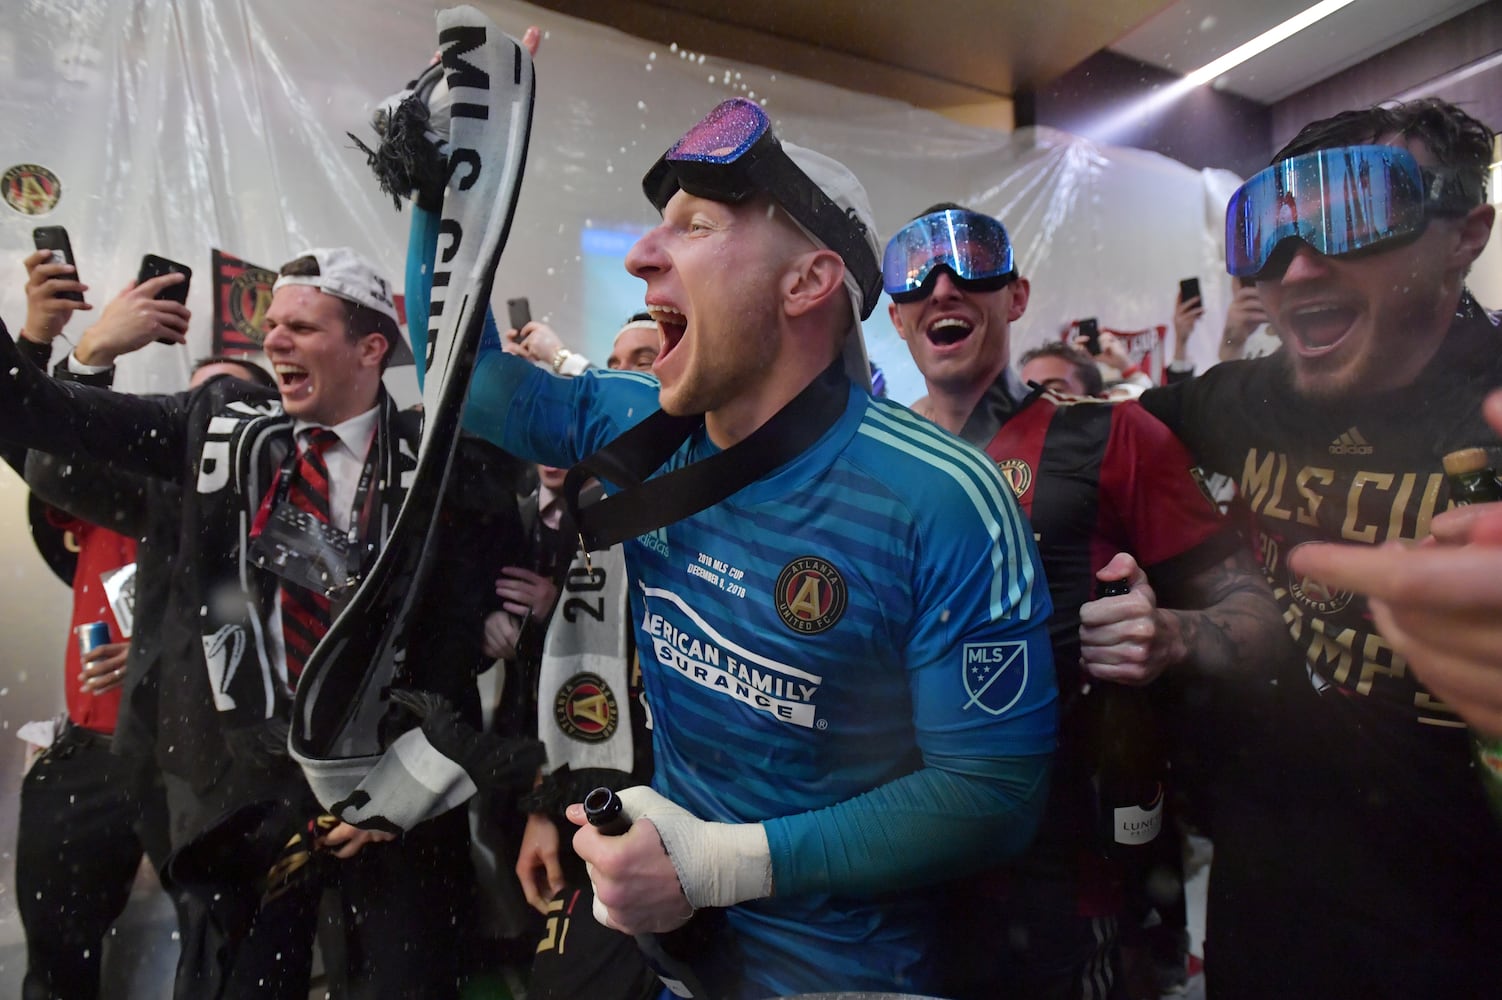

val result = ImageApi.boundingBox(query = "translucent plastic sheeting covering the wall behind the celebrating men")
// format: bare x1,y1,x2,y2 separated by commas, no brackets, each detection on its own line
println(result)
0,0,1235,989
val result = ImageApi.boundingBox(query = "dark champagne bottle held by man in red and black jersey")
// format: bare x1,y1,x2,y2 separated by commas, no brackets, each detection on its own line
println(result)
1086,580,1167,860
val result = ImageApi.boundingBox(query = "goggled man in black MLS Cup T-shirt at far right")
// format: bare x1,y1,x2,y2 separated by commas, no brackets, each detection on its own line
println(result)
1142,99,1502,1000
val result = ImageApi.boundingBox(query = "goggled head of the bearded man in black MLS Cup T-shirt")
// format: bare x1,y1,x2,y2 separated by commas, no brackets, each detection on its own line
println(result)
1226,120,1490,398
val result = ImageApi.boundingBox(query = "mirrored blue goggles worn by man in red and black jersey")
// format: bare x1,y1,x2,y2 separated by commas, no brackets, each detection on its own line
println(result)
882,209,1017,302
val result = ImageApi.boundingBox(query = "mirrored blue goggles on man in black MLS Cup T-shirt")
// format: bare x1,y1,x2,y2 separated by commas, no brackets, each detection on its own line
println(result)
1226,146,1482,278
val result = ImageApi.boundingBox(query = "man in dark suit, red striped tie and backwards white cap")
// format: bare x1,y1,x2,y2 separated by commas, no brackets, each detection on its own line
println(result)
0,248,476,997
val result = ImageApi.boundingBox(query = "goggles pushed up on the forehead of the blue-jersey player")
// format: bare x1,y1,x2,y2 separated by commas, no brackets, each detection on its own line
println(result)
641,98,882,318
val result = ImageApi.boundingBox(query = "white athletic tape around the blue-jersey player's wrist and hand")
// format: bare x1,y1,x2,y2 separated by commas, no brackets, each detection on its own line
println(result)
620,785,772,910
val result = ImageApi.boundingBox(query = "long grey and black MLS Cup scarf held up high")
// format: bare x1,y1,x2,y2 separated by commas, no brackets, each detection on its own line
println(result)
290,6,535,830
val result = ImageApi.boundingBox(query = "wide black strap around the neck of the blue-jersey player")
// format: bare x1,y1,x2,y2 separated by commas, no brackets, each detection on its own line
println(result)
561,360,850,553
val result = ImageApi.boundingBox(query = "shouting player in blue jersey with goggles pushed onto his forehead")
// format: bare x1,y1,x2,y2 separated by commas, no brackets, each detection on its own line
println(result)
466,101,1056,997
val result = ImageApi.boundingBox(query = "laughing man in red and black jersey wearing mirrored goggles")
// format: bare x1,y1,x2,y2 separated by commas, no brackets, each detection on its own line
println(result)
883,204,1283,1000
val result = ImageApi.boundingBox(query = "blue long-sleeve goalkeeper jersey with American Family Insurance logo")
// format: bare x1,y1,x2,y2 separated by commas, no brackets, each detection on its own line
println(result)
466,340,1056,995
